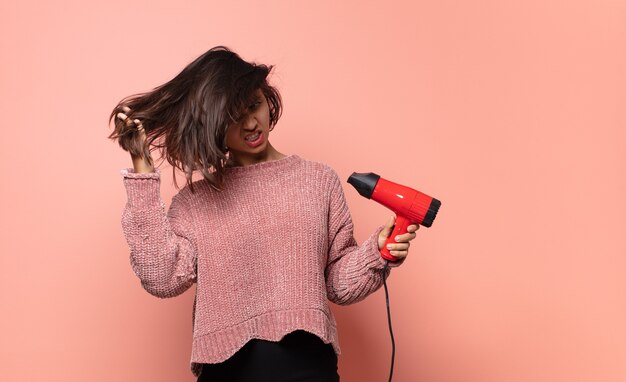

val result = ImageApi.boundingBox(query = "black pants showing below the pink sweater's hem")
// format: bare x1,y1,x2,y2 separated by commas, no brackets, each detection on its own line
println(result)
197,330,339,382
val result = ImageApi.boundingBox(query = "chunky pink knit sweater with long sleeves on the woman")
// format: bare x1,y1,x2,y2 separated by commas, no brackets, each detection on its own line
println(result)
122,155,398,376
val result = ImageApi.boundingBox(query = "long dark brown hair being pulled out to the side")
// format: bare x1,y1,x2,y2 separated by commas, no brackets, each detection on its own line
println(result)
108,46,282,191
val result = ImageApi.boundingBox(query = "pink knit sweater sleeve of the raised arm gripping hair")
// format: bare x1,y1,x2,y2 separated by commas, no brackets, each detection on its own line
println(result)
122,169,196,298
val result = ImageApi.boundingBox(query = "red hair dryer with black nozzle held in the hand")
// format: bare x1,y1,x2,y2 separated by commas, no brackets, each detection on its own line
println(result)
348,172,441,261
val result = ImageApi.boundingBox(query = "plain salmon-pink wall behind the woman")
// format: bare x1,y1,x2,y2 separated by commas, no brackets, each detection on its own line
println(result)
0,0,626,382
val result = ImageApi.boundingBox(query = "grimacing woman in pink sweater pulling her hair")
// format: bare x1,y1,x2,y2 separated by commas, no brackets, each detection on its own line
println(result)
110,46,418,382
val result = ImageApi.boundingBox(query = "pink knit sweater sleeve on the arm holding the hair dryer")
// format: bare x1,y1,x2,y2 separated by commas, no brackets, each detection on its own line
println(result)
326,171,404,305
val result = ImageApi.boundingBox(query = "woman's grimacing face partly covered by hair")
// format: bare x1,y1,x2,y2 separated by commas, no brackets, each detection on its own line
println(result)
226,89,270,165
